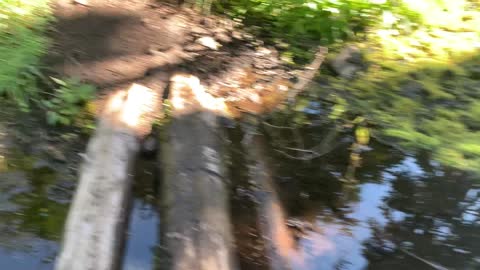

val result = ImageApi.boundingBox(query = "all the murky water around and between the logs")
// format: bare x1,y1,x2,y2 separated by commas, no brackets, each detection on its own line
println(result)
0,126,480,270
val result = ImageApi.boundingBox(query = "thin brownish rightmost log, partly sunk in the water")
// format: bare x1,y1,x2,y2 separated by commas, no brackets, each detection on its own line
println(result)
244,135,295,270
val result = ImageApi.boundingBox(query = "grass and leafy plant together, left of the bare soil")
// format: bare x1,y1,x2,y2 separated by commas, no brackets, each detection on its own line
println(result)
0,0,95,129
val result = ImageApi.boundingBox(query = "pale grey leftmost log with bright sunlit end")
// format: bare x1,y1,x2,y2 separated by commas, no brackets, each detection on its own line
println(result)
55,84,160,270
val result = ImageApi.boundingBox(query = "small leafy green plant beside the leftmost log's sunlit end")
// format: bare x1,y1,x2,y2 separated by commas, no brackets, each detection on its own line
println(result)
41,78,95,125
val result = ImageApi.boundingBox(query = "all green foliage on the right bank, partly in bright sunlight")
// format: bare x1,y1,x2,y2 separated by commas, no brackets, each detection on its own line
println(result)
240,0,480,173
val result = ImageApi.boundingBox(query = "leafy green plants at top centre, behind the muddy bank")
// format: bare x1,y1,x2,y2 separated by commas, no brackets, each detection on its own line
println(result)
219,0,418,62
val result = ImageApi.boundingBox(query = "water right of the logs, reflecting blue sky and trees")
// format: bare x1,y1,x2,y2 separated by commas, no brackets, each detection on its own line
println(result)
270,135,480,269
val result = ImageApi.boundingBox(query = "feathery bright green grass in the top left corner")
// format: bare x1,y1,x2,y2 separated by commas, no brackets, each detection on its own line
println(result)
0,0,51,109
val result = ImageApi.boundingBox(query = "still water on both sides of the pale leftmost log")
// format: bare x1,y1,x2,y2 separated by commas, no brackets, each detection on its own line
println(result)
0,153,159,270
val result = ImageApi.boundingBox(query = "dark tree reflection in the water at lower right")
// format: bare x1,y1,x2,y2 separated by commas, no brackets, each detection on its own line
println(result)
367,159,480,269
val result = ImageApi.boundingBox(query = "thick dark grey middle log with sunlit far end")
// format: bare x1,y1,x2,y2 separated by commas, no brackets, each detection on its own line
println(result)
160,76,237,270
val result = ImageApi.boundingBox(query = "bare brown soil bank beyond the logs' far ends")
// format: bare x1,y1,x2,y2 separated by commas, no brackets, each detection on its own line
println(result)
46,0,293,113
